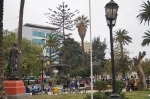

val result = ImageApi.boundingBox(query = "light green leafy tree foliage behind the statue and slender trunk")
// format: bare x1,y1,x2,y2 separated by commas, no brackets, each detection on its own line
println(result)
3,30,42,75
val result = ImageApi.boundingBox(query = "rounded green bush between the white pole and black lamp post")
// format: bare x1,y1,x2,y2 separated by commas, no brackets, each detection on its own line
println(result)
94,80,107,92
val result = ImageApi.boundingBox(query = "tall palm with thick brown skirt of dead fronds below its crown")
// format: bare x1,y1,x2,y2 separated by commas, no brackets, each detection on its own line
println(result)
75,15,89,66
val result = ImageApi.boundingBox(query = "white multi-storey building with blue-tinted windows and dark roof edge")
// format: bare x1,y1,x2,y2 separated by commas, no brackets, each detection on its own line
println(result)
15,23,57,56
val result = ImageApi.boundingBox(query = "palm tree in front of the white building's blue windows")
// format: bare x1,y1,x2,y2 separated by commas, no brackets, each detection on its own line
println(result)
43,33,60,76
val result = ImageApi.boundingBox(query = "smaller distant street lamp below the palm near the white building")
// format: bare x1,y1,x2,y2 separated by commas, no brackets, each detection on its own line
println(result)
36,54,48,92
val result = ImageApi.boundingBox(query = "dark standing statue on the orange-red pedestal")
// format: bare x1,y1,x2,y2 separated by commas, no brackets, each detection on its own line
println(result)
8,43,21,80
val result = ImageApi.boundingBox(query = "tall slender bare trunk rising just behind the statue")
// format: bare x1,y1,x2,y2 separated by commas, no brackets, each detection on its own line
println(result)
17,0,25,79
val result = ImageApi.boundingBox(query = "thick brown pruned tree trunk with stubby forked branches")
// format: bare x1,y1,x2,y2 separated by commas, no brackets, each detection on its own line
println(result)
133,51,147,90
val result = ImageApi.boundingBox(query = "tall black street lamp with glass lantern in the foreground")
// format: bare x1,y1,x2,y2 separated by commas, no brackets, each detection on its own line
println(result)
105,0,120,99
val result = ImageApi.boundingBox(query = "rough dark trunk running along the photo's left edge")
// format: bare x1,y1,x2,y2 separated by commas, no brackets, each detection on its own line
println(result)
0,0,7,99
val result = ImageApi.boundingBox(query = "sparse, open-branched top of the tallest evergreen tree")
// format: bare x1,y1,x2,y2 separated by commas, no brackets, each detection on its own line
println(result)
45,2,79,40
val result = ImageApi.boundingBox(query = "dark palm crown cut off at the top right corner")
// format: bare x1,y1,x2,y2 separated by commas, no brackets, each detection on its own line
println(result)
137,0,150,25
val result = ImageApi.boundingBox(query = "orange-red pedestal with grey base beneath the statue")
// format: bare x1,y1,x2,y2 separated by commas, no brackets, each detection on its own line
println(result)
4,80,27,99
